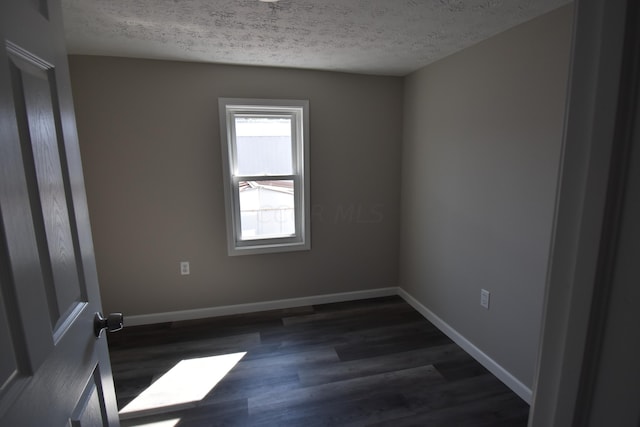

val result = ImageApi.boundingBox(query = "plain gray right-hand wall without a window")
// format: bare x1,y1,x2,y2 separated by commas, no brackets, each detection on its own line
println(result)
400,6,572,387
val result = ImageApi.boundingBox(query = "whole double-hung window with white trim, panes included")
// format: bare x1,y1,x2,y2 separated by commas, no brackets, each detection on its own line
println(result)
218,98,311,255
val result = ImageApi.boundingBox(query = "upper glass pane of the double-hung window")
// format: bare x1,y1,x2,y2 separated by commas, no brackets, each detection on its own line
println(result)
235,117,293,175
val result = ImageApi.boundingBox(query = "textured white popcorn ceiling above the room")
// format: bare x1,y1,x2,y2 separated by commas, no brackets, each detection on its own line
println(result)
62,0,570,76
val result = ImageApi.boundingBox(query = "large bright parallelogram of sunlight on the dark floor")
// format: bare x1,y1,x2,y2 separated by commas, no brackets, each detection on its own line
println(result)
119,352,247,416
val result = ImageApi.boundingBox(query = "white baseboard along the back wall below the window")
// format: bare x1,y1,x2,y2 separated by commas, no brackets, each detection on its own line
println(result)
125,287,398,326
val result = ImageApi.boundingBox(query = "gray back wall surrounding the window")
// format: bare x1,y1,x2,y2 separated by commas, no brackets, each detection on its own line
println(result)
70,56,402,315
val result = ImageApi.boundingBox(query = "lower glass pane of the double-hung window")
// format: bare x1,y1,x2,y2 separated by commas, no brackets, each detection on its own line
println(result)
239,180,295,240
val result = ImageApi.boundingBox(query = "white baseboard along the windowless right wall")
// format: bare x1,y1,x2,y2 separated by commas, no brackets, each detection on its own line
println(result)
398,288,533,404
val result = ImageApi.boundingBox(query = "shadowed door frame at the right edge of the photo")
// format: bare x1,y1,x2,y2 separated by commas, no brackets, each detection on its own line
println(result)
529,0,640,427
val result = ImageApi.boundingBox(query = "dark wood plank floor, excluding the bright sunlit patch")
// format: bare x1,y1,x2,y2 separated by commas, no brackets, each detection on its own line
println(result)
109,297,529,427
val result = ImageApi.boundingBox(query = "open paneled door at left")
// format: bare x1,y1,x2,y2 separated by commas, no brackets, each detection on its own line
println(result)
0,0,119,427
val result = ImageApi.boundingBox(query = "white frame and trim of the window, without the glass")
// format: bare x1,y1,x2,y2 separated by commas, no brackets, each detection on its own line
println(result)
218,98,311,256
